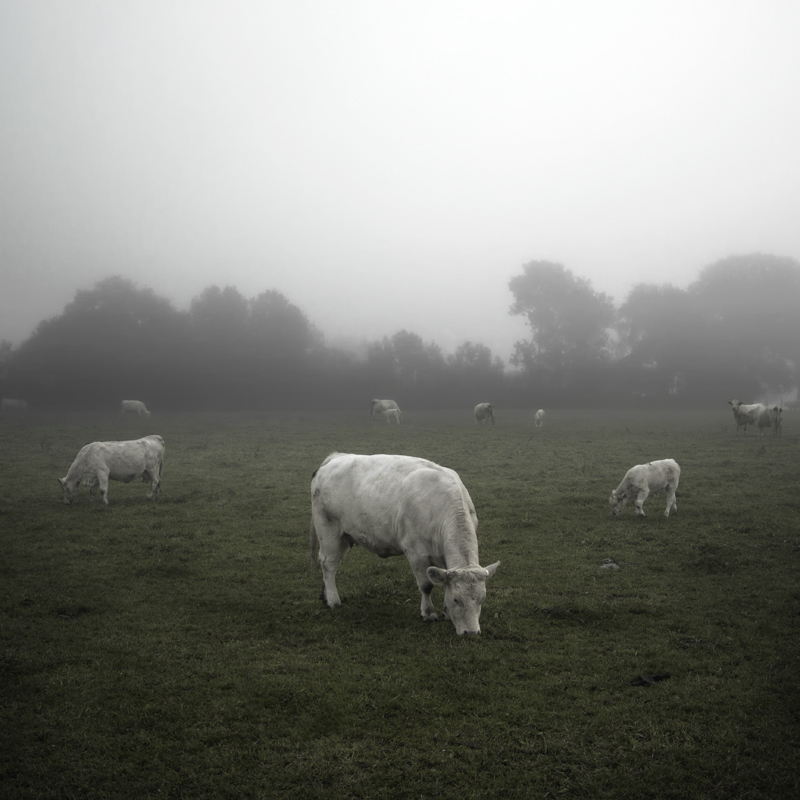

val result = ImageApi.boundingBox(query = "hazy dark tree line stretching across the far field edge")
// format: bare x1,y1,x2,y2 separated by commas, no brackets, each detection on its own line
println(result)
0,254,800,410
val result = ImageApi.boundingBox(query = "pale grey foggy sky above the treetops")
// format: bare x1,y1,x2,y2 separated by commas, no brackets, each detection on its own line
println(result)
0,0,800,358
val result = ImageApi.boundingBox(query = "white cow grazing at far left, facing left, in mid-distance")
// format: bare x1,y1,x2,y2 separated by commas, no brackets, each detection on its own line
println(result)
58,435,164,505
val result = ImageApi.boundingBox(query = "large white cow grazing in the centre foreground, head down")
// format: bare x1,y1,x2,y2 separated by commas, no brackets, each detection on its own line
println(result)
309,453,500,636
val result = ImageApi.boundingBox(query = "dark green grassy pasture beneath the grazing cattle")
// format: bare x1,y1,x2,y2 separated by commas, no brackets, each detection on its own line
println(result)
0,404,800,800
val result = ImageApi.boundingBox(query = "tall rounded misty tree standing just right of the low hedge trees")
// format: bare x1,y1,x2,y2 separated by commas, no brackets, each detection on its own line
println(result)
508,261,615,388
